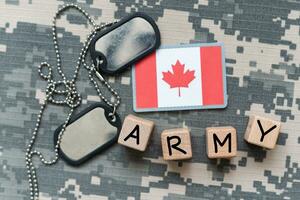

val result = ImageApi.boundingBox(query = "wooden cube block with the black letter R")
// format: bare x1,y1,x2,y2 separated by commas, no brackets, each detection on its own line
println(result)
161,128,192,160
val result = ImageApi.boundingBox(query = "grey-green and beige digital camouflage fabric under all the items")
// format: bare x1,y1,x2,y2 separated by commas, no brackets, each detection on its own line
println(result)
0,0,300,200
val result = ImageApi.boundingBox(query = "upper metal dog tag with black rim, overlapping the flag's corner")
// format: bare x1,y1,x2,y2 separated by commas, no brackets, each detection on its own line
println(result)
90,13,160,74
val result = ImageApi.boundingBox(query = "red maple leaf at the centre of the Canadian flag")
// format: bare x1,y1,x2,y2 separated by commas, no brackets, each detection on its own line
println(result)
163,60,195,96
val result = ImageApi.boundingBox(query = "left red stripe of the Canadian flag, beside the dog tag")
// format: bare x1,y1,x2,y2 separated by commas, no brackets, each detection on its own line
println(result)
135,52,158,108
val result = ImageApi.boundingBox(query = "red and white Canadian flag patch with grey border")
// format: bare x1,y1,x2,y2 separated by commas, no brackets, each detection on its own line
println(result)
133,43,227,112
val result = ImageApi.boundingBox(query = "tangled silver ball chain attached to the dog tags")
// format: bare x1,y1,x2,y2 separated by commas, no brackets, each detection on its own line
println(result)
25,4,120,200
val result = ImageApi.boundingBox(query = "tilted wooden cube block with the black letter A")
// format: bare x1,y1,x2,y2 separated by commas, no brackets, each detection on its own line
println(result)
118,115,154,151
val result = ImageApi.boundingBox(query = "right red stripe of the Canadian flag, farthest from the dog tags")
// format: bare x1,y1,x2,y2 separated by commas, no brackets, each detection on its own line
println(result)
200,46,224,105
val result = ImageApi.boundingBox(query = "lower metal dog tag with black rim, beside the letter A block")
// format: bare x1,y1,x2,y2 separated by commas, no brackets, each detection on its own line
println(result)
54,103,121,165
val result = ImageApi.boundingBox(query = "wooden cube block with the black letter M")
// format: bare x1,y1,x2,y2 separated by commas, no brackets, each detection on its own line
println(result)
206,126,237,158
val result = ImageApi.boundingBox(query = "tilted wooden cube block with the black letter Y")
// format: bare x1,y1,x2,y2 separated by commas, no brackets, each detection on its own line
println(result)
244,115,281,149
